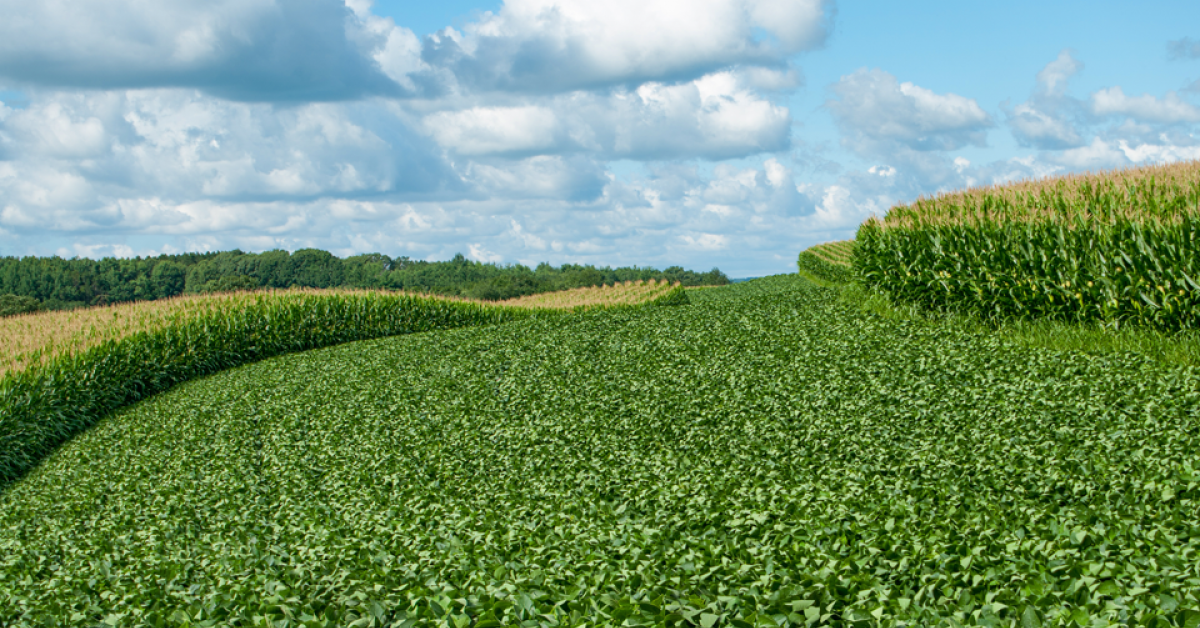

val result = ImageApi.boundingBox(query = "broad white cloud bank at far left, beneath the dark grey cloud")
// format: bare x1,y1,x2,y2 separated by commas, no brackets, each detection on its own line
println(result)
0,90,466,228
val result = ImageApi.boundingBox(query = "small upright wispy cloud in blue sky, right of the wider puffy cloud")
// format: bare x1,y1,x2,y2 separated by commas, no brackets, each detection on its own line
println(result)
1006,50,1085,150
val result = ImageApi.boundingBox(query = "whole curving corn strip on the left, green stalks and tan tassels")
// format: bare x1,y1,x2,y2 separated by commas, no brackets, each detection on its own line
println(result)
0,281,688,489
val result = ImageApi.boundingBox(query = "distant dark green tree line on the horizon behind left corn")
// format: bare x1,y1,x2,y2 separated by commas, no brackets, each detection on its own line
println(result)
0,249,730,315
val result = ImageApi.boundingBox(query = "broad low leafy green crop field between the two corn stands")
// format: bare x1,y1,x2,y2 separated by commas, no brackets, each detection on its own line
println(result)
0,276,1200,628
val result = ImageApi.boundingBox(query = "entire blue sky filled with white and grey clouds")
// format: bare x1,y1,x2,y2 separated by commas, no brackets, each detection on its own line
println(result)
0,0,1200,277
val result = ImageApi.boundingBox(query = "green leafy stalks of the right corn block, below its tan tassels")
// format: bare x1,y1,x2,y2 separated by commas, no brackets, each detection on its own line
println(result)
854,217,1200,331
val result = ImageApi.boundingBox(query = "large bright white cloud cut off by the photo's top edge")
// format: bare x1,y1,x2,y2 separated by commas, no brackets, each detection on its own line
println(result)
422,0,834,92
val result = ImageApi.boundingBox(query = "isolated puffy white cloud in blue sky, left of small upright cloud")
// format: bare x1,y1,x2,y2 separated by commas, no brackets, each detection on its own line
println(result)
826,68,992,154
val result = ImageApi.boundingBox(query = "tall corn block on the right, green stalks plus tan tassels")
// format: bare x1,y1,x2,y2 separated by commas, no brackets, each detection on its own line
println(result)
853,162,1200,331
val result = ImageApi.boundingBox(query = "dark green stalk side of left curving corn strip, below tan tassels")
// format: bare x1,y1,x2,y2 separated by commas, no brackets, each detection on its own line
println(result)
0,294,540,489
